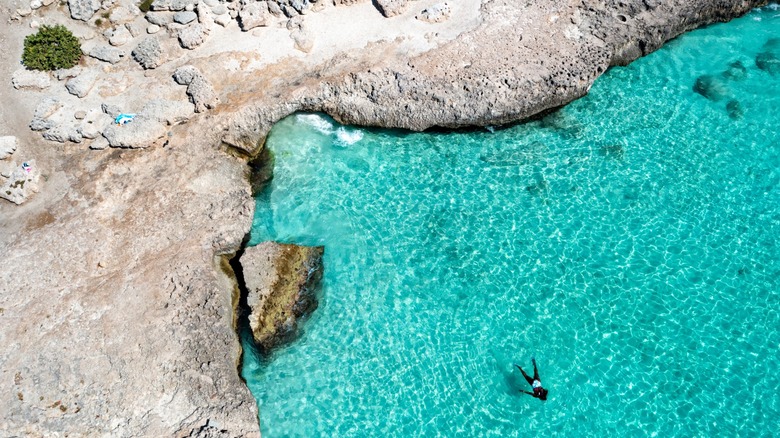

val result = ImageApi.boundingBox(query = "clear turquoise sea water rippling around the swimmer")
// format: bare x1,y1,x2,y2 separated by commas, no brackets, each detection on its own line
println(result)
243,10,780,437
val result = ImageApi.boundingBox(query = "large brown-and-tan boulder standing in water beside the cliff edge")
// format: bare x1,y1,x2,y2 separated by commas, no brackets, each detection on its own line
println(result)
240,242,324,351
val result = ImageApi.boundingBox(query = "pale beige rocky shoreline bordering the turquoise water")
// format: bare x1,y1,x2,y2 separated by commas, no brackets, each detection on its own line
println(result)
0,0,767,436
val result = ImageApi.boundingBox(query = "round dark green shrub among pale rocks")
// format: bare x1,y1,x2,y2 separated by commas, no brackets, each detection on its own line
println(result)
22,24,81,71
